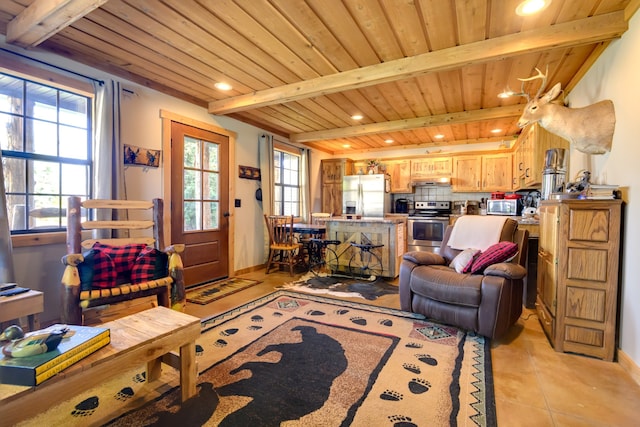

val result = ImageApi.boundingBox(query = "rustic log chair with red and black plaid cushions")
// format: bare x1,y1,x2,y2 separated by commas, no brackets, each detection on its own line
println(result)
61,196,185,324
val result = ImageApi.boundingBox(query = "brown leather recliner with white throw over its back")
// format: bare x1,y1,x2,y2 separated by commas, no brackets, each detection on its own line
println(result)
399,218,529,338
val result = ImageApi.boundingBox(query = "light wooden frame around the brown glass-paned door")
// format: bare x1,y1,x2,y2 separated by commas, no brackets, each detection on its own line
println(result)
160,109,237,277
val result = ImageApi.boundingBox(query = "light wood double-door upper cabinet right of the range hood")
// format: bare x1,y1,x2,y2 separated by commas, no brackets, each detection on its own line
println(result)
452,153,512,192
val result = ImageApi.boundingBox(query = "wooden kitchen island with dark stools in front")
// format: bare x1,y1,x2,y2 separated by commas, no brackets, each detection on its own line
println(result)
326,217,407,278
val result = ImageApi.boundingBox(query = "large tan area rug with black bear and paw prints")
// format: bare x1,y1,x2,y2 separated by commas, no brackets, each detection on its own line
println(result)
16,290,496,427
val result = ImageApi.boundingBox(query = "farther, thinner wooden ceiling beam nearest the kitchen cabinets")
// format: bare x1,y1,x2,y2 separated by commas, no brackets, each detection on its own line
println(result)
289,104,524,142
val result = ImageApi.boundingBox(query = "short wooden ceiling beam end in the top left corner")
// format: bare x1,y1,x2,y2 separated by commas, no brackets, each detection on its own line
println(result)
6,0,107,48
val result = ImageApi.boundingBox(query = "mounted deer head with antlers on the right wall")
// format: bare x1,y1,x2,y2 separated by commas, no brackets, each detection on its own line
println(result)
517,68,616,154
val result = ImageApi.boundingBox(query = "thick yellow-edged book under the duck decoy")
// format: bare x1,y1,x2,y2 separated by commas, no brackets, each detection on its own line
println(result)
0,324,111,386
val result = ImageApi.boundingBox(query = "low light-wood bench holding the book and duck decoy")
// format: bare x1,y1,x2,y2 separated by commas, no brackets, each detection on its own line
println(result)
0,307,200,425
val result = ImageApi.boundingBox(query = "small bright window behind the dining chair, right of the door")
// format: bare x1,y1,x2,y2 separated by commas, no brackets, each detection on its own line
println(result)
273,147,301,217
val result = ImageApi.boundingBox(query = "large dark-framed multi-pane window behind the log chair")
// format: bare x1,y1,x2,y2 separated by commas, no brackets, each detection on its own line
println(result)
0,73,92,234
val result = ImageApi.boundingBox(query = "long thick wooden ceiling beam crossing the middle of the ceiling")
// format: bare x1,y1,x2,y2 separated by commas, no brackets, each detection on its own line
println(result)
209,11,628,114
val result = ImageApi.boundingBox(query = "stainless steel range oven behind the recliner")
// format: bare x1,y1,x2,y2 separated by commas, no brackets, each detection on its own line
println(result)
407,202,451,253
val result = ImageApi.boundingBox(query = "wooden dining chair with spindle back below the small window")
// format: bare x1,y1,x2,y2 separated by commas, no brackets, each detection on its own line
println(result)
264,214,302,276
